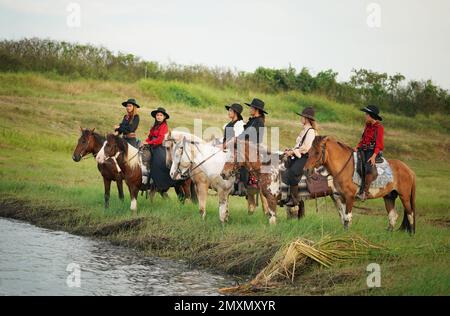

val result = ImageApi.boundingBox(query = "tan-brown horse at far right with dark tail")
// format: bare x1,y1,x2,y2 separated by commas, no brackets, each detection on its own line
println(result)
305,136,416,234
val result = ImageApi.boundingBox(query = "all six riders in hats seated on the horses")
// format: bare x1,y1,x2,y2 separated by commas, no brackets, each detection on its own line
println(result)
114,98,384,206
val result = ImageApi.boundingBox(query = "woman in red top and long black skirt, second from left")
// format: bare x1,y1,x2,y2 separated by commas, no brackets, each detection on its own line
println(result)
145,107,174,191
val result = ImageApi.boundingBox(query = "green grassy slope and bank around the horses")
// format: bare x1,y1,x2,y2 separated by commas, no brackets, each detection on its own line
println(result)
0,73,450,295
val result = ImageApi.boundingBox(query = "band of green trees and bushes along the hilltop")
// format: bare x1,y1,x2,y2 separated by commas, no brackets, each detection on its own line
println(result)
0,38,450,116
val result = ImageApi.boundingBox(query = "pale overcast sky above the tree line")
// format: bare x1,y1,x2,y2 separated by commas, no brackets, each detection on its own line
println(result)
0,0,450,90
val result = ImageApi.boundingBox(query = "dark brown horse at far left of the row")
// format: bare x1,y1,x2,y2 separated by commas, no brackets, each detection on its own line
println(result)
72,127,124,208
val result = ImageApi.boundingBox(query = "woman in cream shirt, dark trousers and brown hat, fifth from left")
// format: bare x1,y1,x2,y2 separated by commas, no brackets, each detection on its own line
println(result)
283,107,317,206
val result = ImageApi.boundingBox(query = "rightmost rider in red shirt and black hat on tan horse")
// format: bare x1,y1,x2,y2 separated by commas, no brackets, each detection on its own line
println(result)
354,105,384,201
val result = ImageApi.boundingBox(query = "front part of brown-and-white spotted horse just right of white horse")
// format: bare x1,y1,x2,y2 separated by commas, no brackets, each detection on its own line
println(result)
221,140,281,224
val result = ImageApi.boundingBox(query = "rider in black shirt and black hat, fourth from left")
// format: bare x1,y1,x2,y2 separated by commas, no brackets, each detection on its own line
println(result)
238,98,269,187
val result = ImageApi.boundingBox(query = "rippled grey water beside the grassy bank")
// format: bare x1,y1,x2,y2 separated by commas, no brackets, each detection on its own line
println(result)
0,218,232,295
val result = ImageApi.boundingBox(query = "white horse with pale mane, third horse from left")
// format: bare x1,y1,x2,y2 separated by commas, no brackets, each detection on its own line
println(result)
165,131,267,223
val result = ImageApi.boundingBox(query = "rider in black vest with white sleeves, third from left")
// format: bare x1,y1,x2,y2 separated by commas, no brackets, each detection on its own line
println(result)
223,103,245,195
